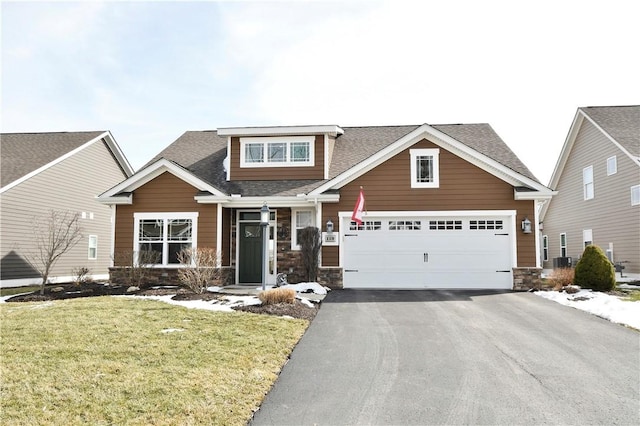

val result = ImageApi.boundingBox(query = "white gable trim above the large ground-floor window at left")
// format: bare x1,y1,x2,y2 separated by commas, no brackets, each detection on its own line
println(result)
99,158,226,198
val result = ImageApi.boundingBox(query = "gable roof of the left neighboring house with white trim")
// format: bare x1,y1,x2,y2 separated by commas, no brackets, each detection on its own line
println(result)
0,131,133,190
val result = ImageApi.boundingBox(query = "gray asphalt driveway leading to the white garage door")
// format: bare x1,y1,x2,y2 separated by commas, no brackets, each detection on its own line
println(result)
251,290,640,426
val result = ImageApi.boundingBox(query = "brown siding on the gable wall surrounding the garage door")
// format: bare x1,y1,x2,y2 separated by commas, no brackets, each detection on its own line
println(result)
322,140,536,267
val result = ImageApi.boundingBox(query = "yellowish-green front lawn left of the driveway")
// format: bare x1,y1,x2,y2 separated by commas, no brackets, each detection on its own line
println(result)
0,297,308,425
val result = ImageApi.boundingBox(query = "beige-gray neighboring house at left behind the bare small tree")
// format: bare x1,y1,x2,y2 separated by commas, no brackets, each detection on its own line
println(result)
0,131,133,287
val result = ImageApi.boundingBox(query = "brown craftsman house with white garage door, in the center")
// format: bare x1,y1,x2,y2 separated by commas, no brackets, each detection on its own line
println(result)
99,124,553,289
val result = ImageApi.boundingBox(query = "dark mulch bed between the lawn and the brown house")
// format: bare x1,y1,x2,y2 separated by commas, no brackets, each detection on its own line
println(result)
6,282,320,321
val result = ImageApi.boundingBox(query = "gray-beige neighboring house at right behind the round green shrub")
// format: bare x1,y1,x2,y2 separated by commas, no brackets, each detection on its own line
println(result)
540,105,640,277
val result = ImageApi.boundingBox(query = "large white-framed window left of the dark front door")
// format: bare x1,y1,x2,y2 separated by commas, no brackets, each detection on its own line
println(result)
134,213,198,266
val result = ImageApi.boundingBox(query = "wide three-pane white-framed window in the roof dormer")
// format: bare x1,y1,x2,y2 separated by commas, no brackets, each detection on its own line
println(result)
240,136,315,167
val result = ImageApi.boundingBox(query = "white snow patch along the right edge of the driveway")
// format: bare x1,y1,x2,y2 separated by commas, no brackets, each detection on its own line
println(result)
535,286,640,330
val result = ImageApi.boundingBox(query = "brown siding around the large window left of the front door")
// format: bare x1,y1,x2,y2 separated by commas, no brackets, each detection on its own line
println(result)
115,173,217,266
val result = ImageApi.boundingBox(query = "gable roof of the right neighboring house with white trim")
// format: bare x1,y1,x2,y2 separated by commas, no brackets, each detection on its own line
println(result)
548,105,640,188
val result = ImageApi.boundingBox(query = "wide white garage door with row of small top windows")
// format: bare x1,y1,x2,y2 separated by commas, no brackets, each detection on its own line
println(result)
342,215,513,289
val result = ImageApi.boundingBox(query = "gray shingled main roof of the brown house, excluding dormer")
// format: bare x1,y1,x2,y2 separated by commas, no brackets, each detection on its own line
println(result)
103,124,548,204
